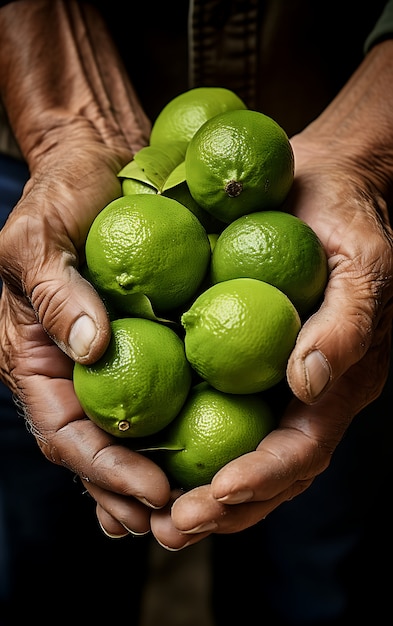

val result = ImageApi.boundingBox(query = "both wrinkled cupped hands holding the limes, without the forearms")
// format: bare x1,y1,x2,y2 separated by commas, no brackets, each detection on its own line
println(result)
0,114,393,549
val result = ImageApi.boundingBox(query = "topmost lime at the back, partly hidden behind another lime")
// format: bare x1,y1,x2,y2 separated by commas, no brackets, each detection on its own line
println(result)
150,87,246,150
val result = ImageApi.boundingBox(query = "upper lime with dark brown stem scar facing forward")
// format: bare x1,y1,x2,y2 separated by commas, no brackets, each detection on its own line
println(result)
185,109,294,223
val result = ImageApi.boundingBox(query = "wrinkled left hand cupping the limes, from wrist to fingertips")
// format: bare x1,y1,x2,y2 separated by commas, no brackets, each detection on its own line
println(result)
0,131,170,536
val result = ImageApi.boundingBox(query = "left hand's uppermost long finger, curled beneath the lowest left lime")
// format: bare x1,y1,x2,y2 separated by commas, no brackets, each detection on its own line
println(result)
2,294,170,520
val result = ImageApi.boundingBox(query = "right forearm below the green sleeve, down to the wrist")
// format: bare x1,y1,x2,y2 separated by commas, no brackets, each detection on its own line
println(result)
296,39,393,203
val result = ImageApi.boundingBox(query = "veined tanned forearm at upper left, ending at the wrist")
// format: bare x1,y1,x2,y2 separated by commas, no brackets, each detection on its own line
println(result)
0,0,150,168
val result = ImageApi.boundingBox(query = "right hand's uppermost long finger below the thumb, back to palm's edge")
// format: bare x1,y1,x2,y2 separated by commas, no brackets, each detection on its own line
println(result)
212,333,390,503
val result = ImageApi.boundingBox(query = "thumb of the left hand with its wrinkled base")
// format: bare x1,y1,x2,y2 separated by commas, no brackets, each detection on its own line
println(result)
0,163,119,363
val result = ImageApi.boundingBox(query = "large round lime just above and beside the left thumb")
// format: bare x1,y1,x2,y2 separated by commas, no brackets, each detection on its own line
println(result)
85,193,211,314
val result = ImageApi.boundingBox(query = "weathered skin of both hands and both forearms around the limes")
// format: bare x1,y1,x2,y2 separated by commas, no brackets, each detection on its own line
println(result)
0,0,393,549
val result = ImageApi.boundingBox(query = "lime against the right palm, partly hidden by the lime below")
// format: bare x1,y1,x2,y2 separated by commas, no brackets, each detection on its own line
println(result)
211,211,328,316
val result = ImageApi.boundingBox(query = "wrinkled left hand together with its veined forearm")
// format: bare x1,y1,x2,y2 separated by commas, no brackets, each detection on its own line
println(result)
0,0,170,536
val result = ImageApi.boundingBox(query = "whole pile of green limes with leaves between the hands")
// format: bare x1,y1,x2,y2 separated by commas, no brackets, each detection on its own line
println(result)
74,88,328,489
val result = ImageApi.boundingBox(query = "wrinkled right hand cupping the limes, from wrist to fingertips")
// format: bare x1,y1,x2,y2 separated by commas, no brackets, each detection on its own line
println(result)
151,135,393,549
